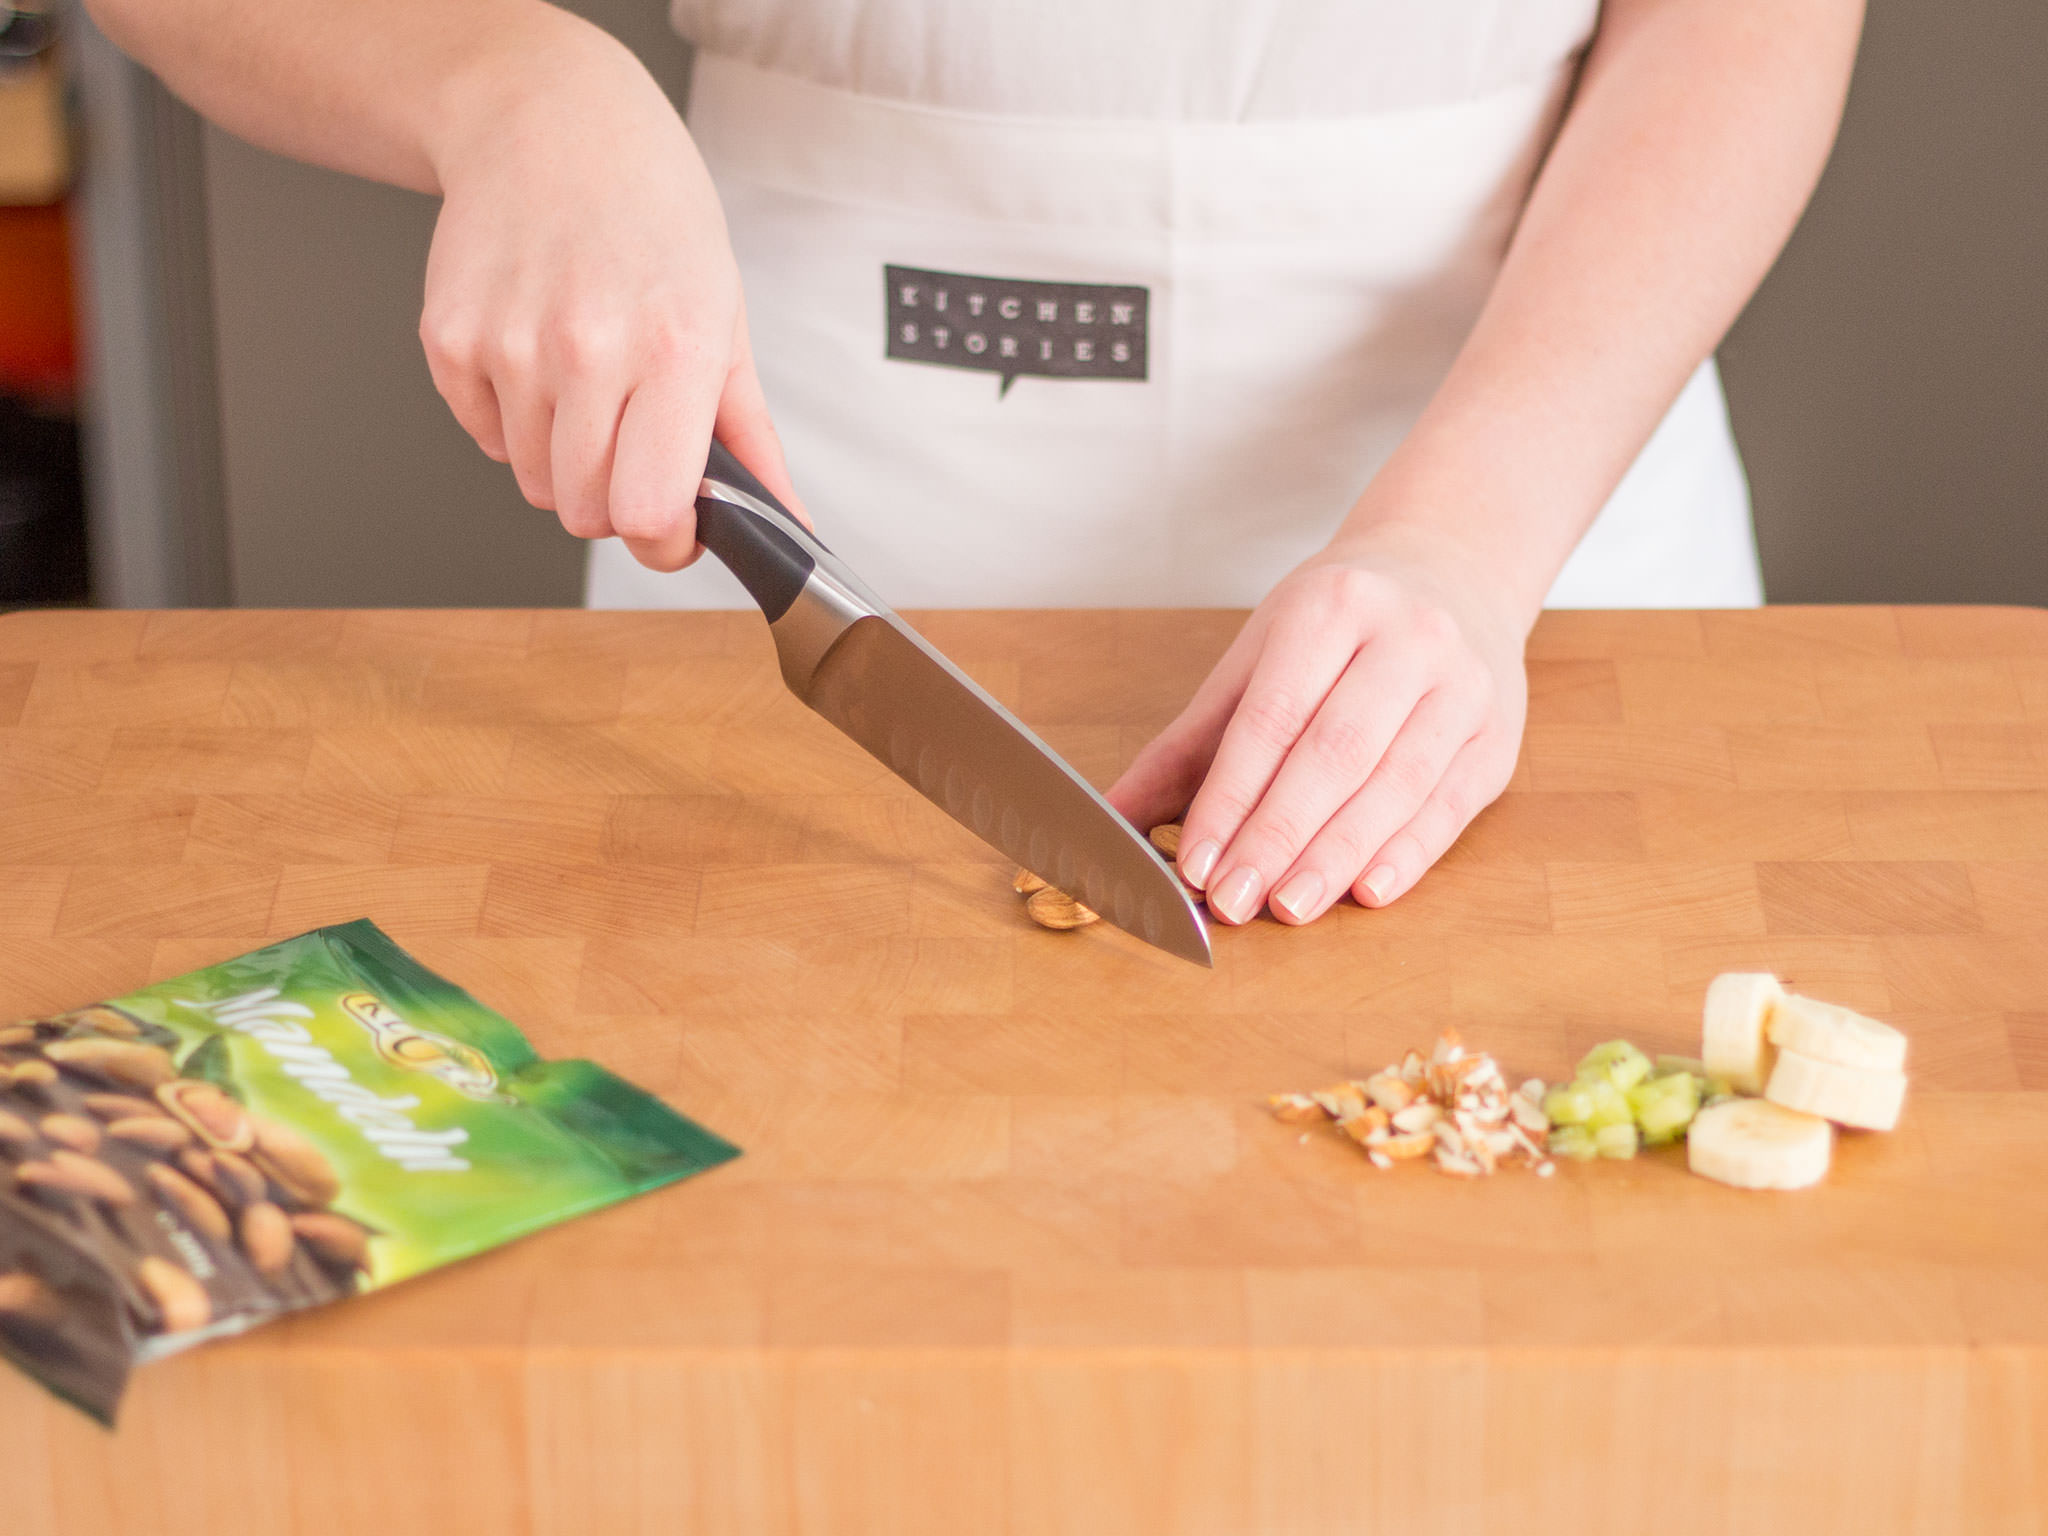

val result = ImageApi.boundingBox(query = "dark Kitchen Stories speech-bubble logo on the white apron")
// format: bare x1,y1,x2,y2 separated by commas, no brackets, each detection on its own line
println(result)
883,266,1151,399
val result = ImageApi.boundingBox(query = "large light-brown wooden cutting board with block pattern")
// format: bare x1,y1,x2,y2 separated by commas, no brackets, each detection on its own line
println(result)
0,608,2048,1536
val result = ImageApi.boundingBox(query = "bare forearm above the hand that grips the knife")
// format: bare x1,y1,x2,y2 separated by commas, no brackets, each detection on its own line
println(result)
86,0,637,193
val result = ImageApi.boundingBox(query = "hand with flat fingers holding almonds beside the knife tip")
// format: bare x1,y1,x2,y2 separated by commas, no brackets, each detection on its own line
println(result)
1110,535,1528,924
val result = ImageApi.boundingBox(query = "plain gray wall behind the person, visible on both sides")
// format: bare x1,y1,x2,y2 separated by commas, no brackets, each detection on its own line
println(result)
195,0,2048,604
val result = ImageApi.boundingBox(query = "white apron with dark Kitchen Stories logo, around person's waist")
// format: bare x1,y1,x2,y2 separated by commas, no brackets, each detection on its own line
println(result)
586,53,1761,608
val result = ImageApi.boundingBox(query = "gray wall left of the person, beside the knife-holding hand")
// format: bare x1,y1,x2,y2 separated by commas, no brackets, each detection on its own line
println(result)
205,0,688,608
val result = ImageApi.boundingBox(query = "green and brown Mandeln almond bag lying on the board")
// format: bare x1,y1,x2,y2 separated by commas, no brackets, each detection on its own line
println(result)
0,922,739,1423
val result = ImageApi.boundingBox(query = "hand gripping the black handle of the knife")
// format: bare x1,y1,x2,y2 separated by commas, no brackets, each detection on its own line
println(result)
420,33,803,571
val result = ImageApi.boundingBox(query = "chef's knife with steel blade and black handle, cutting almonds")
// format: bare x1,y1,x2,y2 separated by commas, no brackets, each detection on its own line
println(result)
696,442,1210,965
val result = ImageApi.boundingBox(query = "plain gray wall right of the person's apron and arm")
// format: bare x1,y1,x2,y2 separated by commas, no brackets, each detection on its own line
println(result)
1722,0,2048,604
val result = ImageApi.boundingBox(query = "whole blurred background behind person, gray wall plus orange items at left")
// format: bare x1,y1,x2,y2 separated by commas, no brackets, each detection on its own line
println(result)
0,0,2048,606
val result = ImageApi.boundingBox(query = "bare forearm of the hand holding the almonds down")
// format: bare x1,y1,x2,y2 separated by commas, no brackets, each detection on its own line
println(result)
1339,0,1862,627
